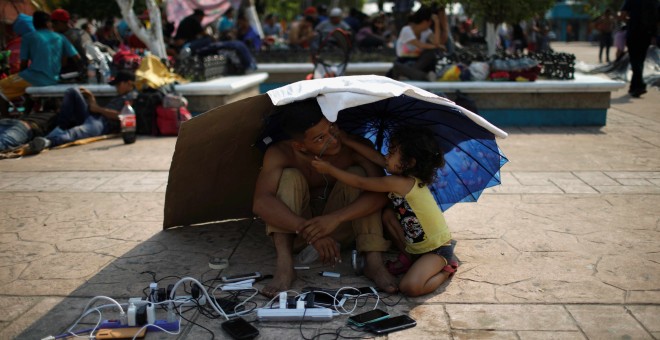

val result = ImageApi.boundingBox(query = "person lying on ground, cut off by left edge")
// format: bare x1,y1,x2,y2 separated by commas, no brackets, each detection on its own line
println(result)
0,112,57,151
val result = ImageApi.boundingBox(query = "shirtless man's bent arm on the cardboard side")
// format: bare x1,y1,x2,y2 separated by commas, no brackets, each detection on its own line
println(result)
252,146,305,232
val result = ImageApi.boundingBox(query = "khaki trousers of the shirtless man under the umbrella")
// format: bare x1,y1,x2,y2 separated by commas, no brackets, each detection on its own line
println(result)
266,166,390,252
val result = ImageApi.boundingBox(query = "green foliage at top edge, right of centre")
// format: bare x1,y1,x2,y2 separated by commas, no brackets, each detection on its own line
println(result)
462,0,556,24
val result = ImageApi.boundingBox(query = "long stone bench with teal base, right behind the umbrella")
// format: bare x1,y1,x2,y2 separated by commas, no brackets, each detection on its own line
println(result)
407,73,626,126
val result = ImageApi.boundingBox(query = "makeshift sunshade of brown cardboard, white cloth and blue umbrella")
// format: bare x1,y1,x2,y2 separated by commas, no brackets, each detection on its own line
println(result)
163,76,507,228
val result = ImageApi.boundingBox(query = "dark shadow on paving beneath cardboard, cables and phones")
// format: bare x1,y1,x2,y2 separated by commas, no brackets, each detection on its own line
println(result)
17,219,420,339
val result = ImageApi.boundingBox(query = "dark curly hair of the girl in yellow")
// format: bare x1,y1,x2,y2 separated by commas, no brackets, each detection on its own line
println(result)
389,126,445,187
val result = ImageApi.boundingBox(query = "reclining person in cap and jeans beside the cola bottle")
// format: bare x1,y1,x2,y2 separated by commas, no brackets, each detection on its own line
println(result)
32,71,138,152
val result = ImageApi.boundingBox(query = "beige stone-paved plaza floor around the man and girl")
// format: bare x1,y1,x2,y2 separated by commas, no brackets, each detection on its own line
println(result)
0,43,660,340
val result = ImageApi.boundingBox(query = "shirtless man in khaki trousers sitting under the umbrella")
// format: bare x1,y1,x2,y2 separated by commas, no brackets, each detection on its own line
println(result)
253,98,398,296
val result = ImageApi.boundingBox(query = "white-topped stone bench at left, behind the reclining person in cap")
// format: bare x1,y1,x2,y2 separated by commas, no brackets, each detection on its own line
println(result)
27,72,268,114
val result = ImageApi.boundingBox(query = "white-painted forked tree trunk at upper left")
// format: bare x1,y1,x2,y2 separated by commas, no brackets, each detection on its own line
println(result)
116,0,167,59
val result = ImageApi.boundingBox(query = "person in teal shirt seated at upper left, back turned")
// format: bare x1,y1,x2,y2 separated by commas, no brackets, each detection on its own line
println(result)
0,11,80,116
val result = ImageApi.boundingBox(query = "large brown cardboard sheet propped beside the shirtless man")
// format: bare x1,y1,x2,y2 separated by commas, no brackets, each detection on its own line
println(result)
163,94,273,229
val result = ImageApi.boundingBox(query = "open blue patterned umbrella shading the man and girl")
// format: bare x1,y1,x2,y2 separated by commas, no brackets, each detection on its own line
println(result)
336,95,508,211
